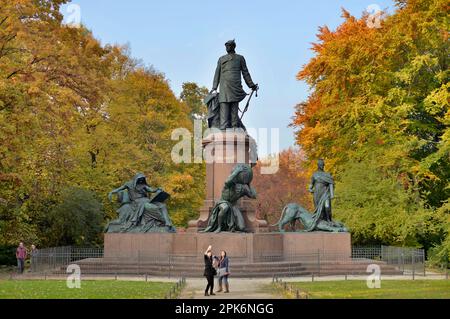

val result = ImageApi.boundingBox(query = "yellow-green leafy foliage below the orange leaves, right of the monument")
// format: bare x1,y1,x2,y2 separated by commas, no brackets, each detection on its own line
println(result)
335,157,443,248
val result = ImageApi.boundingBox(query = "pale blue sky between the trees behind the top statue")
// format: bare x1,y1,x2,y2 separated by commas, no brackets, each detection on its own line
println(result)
63,0,394,149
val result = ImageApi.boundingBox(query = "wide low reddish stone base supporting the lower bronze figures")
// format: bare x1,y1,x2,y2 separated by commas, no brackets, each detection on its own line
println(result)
105,232,352,264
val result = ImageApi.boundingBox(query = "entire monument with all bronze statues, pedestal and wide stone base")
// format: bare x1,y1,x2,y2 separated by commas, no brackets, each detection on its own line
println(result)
105,40,351,271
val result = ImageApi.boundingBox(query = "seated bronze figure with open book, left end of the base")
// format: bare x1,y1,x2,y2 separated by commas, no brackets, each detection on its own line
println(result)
106,173,176,233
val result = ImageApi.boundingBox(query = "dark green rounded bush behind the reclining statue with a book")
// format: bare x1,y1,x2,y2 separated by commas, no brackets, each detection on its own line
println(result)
45,188,104,246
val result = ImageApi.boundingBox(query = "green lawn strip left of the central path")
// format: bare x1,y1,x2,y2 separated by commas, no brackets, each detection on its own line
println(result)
0,279,173,299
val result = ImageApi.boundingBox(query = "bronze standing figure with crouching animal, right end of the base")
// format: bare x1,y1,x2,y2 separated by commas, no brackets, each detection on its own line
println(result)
273,159,348,232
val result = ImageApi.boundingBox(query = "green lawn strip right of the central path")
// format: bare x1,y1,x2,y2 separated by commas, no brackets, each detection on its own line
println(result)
291,280,450,299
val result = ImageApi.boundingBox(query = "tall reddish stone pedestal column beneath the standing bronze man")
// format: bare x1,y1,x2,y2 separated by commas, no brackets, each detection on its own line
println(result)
188,131,268,233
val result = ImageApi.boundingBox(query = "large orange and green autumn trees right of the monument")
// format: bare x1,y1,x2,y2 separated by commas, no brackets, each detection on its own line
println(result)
293,0,450,260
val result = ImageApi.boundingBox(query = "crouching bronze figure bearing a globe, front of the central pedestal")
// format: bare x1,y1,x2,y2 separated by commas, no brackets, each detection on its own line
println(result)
203,164,256,233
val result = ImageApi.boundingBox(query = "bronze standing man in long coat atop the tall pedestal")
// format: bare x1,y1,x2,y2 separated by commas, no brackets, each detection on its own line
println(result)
211,40,258,130
